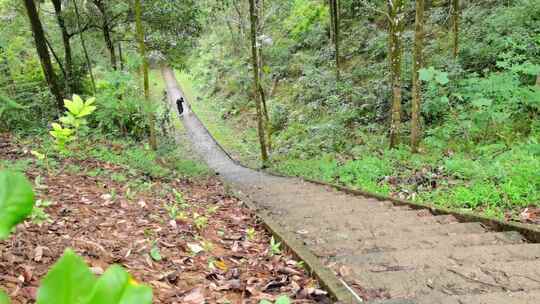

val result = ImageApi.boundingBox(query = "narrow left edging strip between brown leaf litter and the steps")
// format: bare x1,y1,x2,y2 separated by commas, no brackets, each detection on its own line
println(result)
224,182,359,304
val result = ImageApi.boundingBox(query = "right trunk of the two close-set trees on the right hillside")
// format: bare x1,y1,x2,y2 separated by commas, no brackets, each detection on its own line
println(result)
411,0,424,153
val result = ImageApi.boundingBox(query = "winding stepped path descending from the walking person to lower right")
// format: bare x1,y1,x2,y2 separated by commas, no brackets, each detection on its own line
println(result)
162,68,540,304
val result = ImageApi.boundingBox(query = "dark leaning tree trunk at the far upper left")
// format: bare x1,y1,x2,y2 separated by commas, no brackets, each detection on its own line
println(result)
24,0,64,111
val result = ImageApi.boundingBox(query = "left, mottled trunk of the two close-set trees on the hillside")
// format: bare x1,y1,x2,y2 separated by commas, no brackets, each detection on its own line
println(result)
387,0,403,148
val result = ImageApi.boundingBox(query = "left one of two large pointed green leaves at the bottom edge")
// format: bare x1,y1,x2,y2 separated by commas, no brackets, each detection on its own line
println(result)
37,249,97,304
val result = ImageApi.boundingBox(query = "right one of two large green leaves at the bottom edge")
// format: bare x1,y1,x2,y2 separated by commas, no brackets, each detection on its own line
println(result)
85,265,152,304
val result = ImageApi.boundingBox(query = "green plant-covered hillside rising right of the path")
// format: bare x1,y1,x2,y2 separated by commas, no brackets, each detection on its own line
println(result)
184,0,540,223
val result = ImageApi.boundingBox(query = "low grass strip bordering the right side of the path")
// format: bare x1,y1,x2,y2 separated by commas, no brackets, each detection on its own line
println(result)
179,74,540,219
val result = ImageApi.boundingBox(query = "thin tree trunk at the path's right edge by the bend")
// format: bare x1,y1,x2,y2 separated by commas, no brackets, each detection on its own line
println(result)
249,0,268,166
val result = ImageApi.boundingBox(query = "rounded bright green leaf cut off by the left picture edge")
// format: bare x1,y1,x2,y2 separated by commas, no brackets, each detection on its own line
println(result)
0,171,35,240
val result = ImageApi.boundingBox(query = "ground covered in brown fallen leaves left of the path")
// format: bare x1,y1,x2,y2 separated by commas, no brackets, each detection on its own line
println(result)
0,134,327,304
